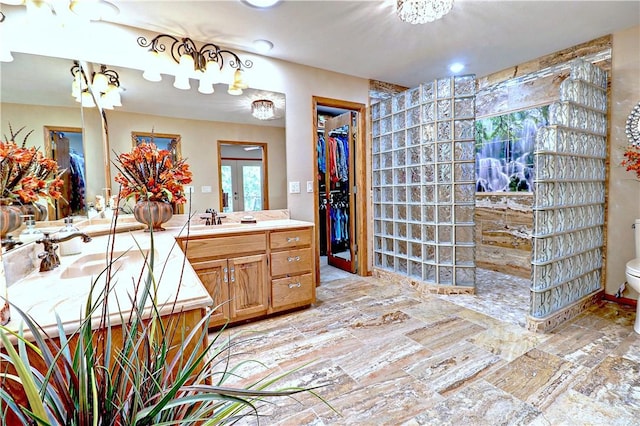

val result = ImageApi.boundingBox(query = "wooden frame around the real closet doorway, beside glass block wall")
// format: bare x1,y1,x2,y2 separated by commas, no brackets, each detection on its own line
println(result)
311,96,371,284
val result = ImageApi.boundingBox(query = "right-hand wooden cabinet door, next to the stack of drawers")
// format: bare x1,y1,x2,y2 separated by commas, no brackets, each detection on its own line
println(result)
229,254,270,320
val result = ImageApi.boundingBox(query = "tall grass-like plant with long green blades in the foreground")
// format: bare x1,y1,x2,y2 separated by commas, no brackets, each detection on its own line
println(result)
0,206,330,426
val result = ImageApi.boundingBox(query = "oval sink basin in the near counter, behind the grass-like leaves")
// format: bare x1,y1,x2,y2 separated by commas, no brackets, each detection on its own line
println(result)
60,249,158,279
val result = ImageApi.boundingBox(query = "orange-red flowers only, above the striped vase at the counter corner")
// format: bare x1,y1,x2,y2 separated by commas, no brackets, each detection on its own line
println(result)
114,142,191,204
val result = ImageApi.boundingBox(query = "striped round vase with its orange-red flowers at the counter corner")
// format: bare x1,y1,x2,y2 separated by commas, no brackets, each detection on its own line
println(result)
114,142,191,231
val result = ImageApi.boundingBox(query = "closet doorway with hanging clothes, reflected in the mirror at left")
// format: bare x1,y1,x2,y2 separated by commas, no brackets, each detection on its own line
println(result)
44,126,87,220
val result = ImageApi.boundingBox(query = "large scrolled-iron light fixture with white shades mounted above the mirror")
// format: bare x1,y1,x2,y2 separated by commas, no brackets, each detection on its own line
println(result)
138,34,253,95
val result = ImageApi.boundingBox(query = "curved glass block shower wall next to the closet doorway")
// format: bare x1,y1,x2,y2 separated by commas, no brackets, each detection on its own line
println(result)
371,75,476,287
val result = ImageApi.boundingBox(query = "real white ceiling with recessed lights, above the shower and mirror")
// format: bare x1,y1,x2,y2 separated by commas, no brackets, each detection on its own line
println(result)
105,0,640,87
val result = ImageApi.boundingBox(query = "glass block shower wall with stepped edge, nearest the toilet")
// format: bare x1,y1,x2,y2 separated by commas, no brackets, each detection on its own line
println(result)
530,59,607,318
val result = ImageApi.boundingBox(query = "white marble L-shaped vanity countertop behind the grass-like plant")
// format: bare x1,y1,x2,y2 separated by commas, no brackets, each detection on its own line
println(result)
7,215,313,338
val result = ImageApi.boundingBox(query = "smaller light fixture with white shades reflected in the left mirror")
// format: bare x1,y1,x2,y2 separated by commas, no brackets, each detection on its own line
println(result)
71,61,122,109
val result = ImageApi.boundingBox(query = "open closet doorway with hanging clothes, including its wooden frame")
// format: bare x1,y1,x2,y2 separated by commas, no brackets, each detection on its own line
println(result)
313,97,369,276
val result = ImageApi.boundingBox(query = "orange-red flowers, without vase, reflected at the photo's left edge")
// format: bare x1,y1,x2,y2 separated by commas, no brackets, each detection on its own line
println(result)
0,125,64,204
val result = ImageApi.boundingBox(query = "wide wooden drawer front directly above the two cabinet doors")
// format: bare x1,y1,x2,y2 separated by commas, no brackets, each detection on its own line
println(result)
182,232,267,260
